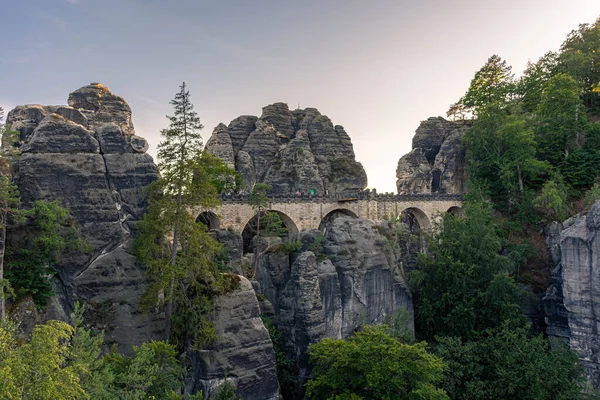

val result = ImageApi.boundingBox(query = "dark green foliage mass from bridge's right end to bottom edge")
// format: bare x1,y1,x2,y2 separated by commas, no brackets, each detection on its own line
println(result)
410,199,584,400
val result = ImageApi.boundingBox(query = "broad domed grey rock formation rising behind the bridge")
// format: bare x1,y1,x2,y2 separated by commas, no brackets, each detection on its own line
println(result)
206,103,367,195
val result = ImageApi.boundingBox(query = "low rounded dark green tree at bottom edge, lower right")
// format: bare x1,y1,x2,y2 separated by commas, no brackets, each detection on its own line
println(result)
435,326,585,400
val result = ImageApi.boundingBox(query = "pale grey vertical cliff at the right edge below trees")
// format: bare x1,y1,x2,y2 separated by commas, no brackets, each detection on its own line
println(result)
544,202,600,387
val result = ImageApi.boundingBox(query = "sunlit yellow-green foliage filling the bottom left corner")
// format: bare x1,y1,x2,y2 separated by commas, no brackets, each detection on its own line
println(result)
0,308,202,400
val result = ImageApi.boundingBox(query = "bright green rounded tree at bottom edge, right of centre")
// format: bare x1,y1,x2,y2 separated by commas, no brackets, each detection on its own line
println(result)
306,325,448,400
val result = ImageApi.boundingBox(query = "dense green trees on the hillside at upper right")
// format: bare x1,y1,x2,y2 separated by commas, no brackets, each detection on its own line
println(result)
448,20,600,223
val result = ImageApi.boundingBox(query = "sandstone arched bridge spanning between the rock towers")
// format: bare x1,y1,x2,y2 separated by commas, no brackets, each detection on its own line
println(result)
196,190,463,233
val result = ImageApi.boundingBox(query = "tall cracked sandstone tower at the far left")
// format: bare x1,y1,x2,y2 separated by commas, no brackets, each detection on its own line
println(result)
7,84,164,352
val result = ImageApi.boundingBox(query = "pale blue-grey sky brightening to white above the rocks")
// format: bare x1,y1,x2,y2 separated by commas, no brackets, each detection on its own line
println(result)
0,0,600,192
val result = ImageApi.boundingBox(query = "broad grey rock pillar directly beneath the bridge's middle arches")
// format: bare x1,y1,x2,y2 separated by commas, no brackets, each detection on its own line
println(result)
256,217,413,392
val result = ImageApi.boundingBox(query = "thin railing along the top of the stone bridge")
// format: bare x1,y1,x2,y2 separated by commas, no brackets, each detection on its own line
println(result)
221,189,464,204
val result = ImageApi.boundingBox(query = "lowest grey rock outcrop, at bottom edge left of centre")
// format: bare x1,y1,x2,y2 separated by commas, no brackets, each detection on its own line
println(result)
188,277,279,400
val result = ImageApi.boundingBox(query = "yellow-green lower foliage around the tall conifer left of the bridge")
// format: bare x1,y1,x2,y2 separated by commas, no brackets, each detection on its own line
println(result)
135,175,223,347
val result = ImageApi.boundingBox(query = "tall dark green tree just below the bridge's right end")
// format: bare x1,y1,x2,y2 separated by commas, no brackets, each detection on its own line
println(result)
409,200,523,340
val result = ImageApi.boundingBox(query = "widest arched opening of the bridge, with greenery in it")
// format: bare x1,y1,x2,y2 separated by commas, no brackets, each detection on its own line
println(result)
242,210,298,254
